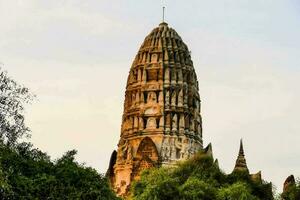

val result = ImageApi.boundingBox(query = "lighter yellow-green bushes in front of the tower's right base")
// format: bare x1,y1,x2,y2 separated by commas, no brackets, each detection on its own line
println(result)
132,153,273,200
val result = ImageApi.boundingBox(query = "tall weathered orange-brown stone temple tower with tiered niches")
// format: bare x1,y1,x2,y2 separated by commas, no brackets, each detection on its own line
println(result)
108,22,203,195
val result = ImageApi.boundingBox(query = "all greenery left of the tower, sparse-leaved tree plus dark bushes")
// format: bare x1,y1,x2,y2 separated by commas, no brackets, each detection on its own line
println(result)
0,68,117,200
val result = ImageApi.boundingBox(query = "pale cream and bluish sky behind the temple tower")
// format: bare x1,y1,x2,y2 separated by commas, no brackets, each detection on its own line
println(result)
0,0,300,191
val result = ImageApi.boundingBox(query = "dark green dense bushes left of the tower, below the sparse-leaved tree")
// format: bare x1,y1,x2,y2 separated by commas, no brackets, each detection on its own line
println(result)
0,143,116,200
